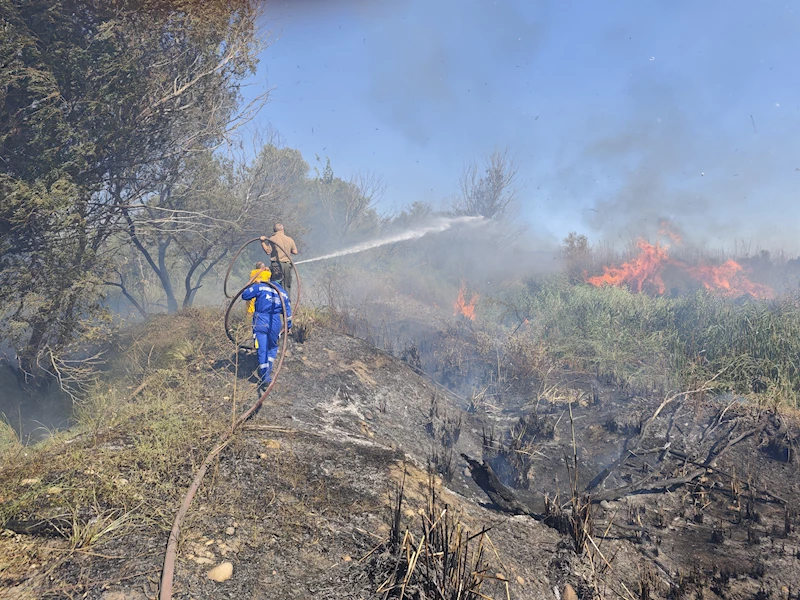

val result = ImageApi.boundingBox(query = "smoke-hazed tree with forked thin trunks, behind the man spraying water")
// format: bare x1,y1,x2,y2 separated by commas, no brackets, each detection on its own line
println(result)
119,142,308,313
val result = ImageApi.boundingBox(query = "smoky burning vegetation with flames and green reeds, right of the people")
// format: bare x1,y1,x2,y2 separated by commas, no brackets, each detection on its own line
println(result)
301,220,800,406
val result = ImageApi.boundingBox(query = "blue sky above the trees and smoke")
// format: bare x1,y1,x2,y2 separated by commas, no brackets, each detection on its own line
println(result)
242,0,800,249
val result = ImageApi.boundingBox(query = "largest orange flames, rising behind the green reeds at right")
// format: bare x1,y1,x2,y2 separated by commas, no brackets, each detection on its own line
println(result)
586,237,775,298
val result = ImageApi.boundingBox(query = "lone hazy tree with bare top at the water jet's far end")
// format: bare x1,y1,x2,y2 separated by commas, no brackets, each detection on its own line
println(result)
453,150,519,221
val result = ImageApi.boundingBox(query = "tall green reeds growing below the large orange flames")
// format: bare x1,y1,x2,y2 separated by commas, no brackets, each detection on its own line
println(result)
497,277,800,407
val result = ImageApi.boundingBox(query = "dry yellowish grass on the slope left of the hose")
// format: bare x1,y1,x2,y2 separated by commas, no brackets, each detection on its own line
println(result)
0,313,233,549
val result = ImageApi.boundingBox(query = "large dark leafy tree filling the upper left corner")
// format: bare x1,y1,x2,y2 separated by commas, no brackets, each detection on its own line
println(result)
0,0,268,378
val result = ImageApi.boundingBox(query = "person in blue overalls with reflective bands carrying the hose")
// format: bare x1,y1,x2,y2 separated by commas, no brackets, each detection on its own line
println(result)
242,269,292,387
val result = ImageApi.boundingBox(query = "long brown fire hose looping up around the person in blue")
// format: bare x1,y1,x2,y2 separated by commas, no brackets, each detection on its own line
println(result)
159,245,300,600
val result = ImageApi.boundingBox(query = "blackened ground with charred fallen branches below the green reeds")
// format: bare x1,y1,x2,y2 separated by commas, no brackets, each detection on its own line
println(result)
478,390,800,598
